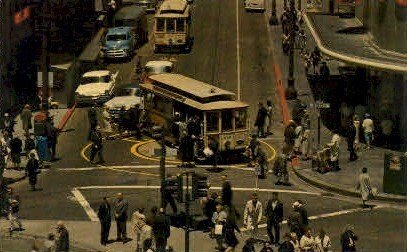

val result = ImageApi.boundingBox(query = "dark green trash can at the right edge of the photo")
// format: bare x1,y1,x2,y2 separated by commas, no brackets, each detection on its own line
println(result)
383,153,407,195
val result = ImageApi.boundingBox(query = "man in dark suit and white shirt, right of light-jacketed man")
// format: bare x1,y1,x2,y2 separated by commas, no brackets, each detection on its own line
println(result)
266,192,284,244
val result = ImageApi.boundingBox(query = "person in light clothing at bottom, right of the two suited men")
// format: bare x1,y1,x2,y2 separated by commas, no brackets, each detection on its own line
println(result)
131,208,152,252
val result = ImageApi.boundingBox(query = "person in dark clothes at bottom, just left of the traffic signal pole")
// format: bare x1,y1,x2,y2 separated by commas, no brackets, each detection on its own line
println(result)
152,208,171,252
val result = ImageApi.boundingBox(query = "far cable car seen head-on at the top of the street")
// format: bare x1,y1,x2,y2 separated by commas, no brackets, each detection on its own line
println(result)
154,0,192,52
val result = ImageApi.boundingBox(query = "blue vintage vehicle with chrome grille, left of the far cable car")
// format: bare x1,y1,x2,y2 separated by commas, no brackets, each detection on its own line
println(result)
100,27,137,59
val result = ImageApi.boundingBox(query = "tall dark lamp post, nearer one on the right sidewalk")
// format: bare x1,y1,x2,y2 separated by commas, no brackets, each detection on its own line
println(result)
285,0,297,100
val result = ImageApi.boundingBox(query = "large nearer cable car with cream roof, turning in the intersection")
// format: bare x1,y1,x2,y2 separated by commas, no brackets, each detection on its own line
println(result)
140,73,250,157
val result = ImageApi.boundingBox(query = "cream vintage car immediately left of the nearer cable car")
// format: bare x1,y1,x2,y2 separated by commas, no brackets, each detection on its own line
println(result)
103,83,143,120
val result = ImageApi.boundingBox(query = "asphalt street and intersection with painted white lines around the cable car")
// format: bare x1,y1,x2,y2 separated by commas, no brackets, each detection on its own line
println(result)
3,0,407,251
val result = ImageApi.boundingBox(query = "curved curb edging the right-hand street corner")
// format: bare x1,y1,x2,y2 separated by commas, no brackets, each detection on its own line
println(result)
293,166,407,203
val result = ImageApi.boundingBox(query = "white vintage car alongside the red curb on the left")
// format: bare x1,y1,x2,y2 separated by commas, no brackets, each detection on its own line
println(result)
75,70,119,105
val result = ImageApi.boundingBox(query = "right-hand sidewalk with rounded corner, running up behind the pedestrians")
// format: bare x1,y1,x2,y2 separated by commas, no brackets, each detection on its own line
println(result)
267,0,407,202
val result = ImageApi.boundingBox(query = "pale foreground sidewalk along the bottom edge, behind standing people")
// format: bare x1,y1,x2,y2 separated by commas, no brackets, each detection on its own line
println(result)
0,219,266,252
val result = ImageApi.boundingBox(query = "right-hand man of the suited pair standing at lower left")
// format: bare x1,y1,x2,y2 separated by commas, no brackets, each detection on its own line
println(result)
114,193,129,244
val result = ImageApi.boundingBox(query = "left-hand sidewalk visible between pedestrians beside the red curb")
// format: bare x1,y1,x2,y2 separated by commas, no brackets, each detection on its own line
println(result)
3,107,75,184
